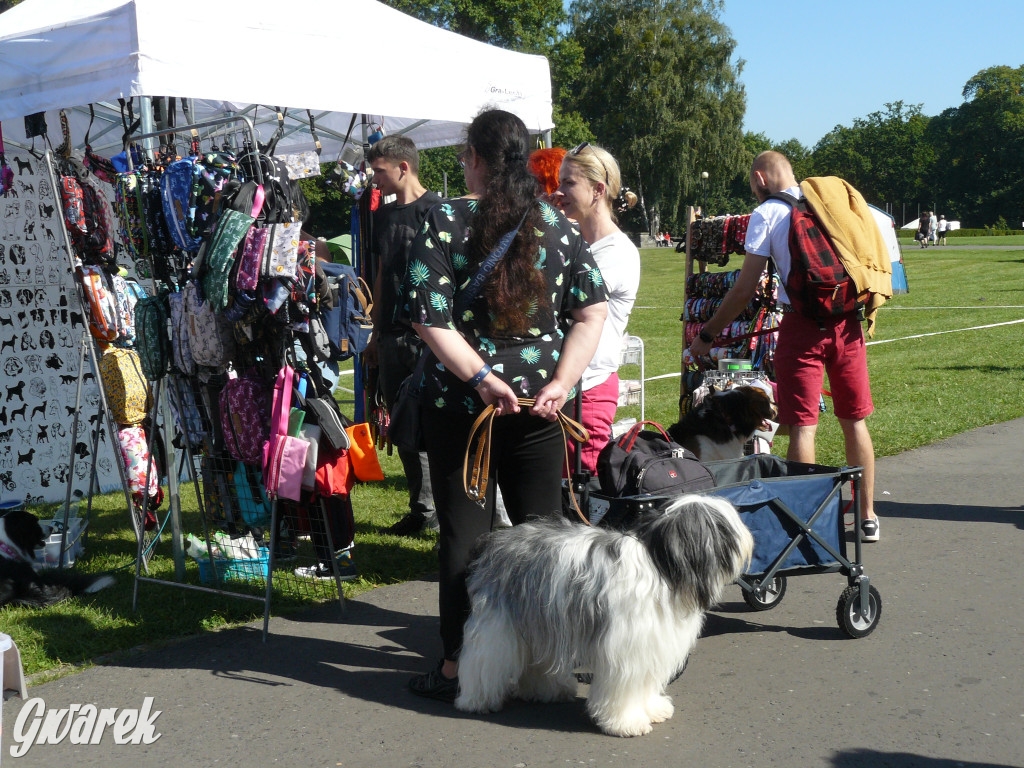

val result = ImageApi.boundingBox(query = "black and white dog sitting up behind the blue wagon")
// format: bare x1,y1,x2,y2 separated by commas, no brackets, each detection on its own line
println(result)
667,384,778,462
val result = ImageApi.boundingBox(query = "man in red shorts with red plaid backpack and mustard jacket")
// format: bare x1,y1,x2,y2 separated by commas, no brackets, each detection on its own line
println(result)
689,152,891,542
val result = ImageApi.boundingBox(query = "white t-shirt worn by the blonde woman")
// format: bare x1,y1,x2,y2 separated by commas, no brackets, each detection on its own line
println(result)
583,231,640,390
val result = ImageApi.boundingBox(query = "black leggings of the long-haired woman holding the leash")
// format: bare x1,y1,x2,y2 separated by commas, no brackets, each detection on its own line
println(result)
423,403,565,659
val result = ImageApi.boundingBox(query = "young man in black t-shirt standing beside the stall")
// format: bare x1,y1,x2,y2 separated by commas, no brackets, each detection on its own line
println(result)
364,136,441,536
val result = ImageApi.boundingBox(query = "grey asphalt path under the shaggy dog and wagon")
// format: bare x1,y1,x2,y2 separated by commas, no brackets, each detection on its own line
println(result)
3,420,1024,768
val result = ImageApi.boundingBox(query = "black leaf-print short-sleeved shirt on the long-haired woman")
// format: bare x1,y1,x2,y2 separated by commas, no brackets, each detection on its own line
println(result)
406,198,607,414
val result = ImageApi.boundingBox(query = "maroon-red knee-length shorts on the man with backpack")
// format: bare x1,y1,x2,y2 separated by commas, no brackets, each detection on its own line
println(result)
775,312,874,426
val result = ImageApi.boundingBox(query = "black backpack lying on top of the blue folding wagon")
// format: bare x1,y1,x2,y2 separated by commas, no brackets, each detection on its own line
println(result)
597,421,715,497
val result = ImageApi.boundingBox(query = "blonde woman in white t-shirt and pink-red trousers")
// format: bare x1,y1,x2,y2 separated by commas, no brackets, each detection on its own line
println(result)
554,141,640,474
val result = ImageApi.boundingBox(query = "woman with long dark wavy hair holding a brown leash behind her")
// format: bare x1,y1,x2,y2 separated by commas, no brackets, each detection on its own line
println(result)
408,110,606,700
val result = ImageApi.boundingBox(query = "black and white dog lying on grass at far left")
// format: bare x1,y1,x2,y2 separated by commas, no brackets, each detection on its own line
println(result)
0,510,115,608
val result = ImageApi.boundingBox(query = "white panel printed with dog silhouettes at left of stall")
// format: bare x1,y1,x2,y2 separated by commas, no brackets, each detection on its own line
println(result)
0,153,121,504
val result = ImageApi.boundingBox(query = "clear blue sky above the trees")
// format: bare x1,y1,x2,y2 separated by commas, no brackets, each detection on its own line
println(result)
721,0,1024,148
